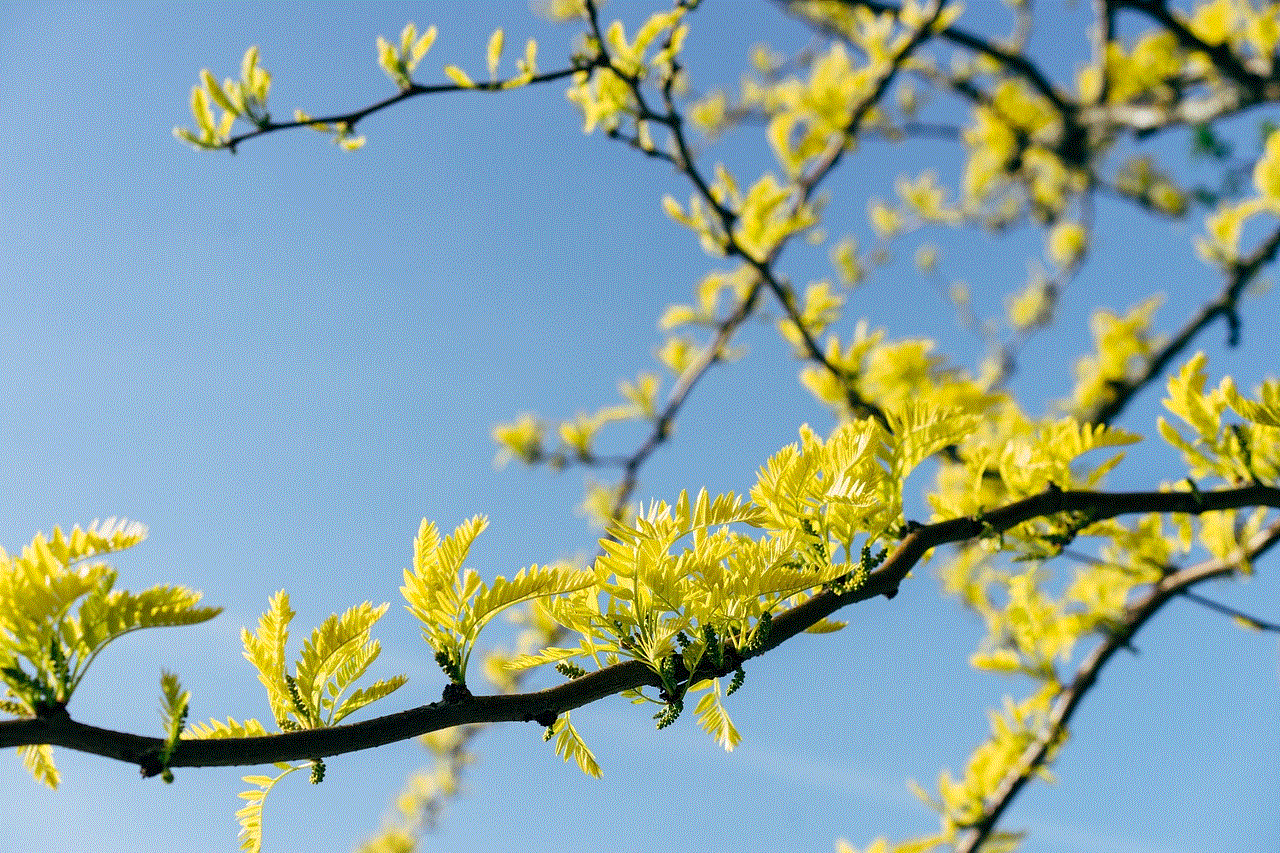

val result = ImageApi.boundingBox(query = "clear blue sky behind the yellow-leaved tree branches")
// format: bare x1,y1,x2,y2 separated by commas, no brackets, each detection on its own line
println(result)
0,0,1280,853
